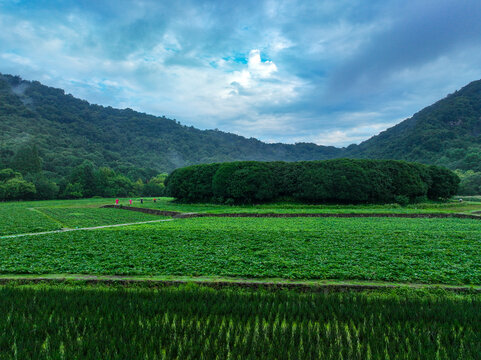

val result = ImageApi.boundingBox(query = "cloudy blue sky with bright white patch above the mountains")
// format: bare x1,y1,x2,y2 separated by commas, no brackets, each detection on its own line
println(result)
0,0,481,146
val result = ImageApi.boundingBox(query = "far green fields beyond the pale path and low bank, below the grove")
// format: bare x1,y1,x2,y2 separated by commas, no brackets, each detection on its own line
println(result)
0,198,481,236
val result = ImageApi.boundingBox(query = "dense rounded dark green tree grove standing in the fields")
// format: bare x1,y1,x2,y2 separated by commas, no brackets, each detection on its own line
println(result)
166,159,459,204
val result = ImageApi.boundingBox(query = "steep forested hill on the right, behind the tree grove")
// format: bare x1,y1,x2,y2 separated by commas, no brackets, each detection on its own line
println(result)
344,80,481,171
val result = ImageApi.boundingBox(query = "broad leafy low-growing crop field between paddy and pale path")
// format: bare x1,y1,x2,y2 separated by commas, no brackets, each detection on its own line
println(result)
0,218,481,284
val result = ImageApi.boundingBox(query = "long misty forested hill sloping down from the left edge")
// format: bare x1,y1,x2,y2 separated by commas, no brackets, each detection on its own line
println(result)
0,74,342,178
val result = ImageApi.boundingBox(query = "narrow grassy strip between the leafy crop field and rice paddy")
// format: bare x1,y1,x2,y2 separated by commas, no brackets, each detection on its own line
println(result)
0,274,481,293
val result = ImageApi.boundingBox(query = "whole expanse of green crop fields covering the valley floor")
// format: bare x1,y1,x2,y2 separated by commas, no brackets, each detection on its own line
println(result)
0,198,481,359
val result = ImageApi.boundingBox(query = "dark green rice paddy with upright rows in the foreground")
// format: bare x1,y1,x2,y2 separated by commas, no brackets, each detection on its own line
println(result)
0,284,481,360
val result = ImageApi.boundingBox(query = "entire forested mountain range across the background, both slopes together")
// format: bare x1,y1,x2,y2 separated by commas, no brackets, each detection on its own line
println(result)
0,74,481,178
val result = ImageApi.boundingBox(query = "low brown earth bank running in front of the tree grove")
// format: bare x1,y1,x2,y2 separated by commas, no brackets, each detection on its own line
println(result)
102,205,481,220
